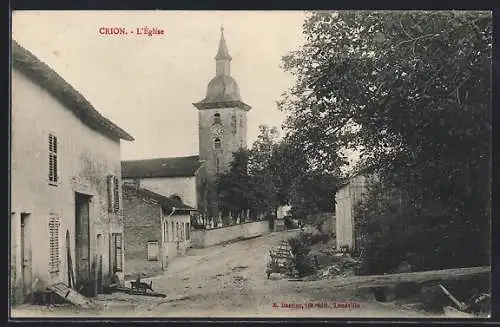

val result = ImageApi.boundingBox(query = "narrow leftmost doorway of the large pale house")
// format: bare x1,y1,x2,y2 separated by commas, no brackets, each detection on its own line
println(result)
21,213,32,302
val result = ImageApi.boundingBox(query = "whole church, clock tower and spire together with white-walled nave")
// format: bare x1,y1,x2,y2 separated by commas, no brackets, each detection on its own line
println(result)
122,28,251,217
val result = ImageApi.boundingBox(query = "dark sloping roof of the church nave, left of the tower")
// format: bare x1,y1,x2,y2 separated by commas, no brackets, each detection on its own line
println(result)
122,156,202,178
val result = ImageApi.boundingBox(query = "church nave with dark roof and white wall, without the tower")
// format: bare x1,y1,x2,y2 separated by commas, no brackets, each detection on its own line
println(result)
122,156,204,213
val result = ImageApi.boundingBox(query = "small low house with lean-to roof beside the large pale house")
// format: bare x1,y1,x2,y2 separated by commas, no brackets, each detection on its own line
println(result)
123,183,196,275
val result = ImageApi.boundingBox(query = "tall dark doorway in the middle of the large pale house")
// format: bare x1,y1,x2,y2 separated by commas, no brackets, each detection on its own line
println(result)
75,193,93,296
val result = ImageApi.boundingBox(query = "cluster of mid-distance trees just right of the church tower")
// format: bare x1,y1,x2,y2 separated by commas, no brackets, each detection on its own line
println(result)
217,125,337,220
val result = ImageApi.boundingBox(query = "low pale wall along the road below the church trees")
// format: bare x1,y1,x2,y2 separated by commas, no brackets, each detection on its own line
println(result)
191,220,269,248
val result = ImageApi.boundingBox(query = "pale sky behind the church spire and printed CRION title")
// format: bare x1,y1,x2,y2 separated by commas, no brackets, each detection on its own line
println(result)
12,11,305,159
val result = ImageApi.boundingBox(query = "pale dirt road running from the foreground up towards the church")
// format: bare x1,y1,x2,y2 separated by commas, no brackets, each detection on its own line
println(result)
11,232,440,317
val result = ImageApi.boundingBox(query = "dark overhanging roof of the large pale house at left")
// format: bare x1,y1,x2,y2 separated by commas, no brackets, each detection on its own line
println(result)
12,40,134,141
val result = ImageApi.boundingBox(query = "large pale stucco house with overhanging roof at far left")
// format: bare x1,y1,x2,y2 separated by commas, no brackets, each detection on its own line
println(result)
10,42,134,302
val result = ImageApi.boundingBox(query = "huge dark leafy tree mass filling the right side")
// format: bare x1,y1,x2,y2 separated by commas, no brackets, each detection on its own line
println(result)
279,11,492,270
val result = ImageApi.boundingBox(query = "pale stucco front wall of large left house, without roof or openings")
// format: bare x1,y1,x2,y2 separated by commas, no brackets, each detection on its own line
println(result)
11,69,123,304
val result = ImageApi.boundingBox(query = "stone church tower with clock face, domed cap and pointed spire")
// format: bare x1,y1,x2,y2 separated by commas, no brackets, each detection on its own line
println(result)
193,27,251,215
